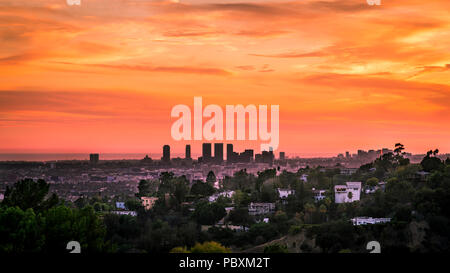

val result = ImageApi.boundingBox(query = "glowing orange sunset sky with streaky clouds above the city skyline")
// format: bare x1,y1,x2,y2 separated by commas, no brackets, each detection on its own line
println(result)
0,0,450,156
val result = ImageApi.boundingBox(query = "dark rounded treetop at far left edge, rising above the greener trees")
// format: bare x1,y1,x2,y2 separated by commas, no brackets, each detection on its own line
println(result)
2,178,59,212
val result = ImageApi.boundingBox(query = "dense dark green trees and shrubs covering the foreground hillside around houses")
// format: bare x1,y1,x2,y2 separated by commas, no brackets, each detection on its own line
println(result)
0,144,450,253
